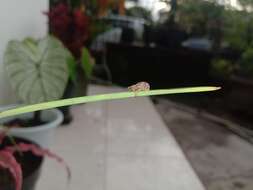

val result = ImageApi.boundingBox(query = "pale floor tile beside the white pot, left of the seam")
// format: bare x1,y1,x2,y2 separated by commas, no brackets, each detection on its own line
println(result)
53,104,106,153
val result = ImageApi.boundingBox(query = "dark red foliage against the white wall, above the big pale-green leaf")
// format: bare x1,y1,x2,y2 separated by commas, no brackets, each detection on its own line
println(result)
46,3,89,58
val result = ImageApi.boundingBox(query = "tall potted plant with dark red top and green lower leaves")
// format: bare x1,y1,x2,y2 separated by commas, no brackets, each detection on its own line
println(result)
46,1,95,124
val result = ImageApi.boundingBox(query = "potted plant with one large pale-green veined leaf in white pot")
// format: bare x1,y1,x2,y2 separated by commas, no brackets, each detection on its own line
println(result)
0,36,71,148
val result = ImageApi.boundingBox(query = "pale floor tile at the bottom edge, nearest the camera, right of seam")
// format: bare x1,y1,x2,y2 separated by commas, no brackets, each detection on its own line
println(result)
106,156,204,190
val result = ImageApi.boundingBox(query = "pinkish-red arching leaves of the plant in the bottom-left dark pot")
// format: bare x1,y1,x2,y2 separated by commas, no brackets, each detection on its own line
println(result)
0,132,71,190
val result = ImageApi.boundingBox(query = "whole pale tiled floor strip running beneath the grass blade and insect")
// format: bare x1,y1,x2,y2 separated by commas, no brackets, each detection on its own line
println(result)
37,86,204,190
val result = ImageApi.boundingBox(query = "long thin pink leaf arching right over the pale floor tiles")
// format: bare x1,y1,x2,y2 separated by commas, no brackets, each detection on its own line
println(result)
6,143,71,180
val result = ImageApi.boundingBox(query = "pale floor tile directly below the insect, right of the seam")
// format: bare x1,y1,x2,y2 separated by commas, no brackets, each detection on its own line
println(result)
107,97,183,156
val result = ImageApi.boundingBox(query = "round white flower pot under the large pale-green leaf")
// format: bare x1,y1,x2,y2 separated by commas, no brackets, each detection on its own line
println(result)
0,105,63,148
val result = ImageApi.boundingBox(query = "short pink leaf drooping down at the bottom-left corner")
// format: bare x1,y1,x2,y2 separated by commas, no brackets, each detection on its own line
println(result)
0,150,23,190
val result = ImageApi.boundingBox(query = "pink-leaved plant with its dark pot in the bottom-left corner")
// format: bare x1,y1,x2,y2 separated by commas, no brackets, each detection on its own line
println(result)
0,132,70,190
